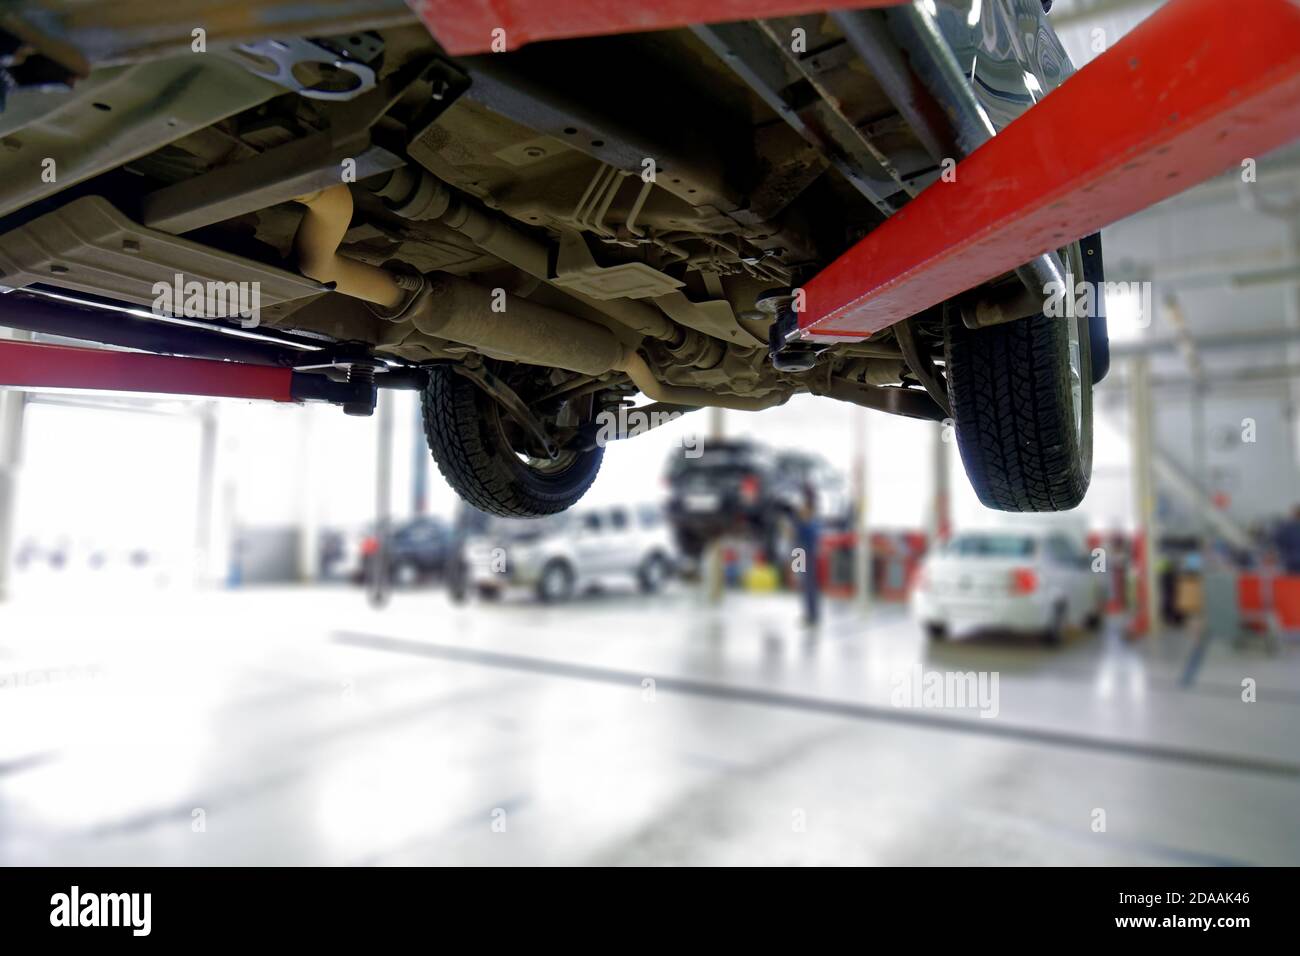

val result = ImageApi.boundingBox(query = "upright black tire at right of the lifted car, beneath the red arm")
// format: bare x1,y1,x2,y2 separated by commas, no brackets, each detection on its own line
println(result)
944,290,1092,511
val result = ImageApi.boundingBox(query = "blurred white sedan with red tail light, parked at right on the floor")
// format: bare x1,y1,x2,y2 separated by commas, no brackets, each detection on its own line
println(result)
911,531,1105,644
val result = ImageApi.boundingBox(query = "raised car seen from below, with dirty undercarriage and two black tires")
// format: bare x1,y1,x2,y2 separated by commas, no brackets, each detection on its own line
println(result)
0,0,1106,516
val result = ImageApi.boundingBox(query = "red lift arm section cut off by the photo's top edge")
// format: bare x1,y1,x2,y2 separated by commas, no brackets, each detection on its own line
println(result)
407,0,898,56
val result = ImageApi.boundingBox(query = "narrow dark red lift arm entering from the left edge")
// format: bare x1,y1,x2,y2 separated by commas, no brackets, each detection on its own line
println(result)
0,342,294,402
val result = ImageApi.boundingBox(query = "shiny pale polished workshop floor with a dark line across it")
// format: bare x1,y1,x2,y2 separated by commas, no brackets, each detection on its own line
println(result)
0,589,1300,865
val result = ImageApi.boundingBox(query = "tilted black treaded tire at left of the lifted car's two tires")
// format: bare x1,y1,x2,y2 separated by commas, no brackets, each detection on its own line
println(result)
423,365,605,518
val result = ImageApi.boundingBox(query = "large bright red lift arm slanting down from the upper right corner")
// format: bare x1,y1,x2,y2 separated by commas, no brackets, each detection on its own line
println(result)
800,0,1300,341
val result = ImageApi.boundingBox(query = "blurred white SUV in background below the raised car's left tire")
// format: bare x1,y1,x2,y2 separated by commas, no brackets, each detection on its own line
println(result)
464,506,676,602
